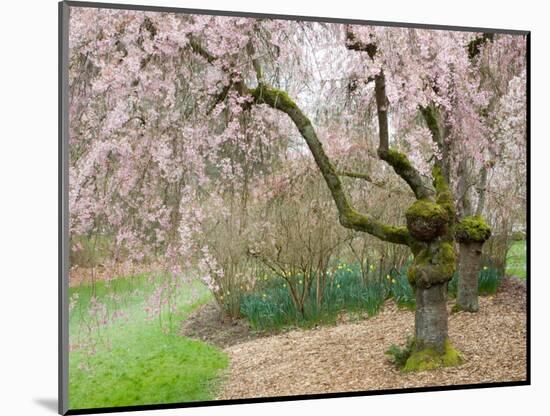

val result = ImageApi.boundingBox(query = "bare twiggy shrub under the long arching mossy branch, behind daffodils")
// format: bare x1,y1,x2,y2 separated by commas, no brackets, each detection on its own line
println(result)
249,163,350,319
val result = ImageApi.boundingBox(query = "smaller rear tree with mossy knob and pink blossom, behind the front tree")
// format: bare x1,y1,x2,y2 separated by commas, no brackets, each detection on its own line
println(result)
455,33,526,312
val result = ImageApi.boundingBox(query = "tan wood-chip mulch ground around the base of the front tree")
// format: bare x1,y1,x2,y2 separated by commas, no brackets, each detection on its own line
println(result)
211,278,527,399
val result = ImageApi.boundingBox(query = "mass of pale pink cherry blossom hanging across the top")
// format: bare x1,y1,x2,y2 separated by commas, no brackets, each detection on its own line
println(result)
69,8,526,313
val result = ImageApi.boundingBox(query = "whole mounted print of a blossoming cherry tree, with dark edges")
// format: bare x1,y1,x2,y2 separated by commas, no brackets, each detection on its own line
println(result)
59,1,530,414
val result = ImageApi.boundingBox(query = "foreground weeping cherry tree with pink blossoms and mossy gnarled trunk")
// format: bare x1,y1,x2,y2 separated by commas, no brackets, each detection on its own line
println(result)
70,8,525,369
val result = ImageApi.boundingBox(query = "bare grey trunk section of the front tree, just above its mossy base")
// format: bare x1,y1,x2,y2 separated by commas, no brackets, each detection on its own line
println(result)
415,282,448,353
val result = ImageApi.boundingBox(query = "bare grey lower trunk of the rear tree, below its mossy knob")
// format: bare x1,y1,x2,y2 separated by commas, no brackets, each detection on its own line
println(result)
456,242,482,312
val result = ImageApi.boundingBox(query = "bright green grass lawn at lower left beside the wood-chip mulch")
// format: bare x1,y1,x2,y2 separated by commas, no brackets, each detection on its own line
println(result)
69,276,228,409
